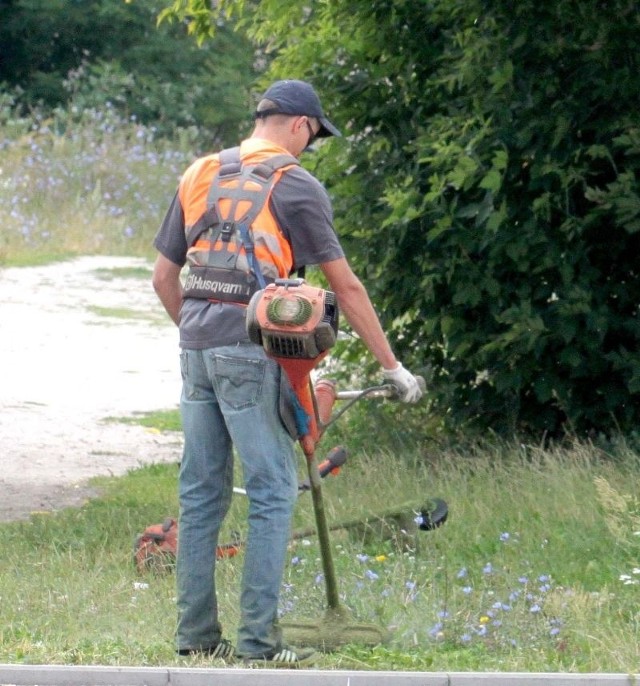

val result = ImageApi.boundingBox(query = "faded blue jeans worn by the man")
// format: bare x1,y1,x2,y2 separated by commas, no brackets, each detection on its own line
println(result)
177,344,298,657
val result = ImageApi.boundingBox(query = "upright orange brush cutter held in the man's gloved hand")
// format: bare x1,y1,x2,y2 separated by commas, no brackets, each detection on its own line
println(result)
246,279,447,651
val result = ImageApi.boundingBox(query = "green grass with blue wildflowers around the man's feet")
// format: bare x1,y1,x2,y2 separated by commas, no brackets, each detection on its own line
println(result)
0,436,640,673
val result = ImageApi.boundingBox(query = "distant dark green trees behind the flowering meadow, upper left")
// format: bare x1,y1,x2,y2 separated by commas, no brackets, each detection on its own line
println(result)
0,0,256,143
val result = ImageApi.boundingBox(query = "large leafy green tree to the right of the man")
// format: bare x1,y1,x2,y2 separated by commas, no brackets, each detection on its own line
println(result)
125,0,640,434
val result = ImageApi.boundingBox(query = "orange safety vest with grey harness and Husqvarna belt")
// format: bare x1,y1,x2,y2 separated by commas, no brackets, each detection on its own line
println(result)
178,140,299,305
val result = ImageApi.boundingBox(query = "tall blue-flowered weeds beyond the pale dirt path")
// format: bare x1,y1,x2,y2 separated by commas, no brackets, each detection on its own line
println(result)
0,91,194,265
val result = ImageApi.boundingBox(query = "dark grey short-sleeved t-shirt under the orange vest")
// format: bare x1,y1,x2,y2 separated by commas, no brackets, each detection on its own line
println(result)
154,160,344,350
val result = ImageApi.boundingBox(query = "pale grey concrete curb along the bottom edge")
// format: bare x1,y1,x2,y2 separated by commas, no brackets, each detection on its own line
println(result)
0,664,640,686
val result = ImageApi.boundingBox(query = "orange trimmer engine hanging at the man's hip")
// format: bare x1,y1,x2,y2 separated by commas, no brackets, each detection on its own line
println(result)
247,279,338,360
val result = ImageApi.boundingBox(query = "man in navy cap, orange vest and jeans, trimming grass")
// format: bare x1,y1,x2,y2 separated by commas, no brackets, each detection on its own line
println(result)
153,80,421,667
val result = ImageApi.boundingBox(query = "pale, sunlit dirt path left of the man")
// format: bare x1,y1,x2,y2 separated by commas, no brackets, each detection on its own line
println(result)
0,257,181,521
